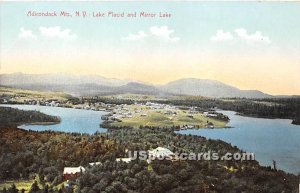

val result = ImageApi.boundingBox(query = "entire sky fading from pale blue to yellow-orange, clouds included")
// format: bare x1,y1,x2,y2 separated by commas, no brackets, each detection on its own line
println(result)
0,2,300,94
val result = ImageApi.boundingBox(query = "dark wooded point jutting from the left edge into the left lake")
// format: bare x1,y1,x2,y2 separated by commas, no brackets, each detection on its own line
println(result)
0,107,60,127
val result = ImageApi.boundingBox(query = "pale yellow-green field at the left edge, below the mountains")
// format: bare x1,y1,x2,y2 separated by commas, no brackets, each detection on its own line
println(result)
0,87,69,103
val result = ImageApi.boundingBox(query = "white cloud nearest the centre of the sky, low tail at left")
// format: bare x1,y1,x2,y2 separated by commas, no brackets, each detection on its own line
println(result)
121,26,180,42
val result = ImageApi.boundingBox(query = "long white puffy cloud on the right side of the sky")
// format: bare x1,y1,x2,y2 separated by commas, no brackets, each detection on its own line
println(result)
210,28,271,44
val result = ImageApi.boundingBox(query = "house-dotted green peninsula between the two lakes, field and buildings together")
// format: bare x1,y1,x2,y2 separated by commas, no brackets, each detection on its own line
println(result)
102,101,228,129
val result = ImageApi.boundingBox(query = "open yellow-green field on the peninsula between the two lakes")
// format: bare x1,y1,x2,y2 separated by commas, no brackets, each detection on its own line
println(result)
112,105,226,128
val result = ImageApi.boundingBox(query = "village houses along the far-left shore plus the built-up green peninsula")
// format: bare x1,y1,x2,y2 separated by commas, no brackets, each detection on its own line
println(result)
2,97,228,129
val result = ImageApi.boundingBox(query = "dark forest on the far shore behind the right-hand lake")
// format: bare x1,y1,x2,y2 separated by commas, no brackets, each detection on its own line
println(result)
152,97,300,124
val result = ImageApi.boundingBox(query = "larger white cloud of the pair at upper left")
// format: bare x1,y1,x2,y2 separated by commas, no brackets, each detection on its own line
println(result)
39,26,77,40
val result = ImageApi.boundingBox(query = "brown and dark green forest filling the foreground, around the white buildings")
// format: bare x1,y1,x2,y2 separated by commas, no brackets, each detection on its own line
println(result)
0,127,298,193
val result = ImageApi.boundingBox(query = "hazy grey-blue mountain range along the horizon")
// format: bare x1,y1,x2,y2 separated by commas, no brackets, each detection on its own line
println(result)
0,73,273,98
